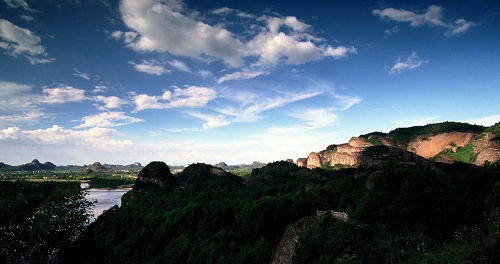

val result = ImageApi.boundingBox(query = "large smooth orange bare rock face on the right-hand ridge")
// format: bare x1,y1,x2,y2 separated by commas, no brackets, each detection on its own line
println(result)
407,132,477,159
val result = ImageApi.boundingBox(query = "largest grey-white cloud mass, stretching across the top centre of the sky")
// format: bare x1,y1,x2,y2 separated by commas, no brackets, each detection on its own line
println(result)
117,0,356,73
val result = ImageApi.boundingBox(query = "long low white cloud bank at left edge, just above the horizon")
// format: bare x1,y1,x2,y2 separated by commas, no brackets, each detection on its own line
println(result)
0,125,132,150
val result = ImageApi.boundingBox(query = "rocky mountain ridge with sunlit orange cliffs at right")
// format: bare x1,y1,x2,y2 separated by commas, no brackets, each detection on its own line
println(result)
296,122,500,168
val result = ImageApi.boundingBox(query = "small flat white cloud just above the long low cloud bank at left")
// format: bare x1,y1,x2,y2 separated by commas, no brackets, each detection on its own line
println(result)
75,112,145,128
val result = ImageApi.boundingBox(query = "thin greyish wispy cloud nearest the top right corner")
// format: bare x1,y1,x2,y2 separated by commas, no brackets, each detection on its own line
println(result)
372,5,476,36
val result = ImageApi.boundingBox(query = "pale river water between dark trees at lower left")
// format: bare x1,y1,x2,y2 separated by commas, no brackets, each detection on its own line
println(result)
81,183,128,218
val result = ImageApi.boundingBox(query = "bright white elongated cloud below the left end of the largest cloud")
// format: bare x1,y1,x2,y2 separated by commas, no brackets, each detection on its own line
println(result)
134,86,217,111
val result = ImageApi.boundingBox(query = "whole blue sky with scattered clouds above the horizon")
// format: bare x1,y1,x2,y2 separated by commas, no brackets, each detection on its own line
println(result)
0,0,500,166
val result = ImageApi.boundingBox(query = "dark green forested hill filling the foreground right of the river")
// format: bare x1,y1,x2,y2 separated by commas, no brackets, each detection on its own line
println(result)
61,156,500,263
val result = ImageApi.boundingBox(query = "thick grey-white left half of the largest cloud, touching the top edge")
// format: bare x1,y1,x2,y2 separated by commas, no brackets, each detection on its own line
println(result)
120,0,244,67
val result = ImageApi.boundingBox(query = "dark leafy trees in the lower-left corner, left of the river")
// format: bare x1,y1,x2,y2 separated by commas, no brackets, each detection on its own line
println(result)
0,181,92,263
